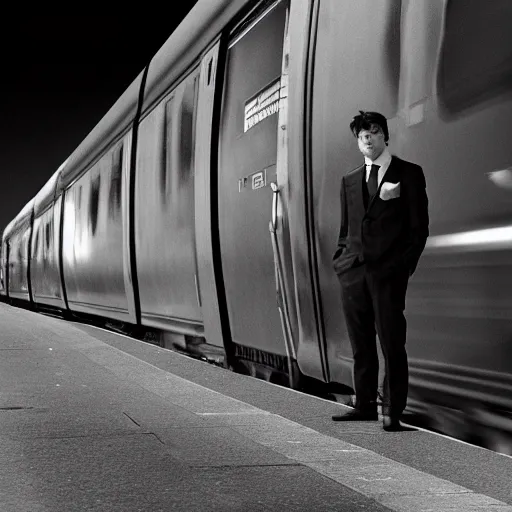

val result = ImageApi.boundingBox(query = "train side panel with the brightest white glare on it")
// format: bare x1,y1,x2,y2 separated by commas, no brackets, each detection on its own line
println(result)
62,141,133,321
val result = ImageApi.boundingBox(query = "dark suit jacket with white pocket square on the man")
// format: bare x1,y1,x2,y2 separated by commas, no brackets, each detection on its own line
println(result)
333,156,429,276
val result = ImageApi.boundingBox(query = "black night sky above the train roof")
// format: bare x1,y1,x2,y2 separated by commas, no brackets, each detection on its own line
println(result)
0,7,196,233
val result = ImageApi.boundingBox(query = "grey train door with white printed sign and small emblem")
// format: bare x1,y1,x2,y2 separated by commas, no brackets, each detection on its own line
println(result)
218,0,289,372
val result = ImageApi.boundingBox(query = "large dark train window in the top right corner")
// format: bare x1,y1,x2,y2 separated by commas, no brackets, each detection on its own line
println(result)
438,0,512,114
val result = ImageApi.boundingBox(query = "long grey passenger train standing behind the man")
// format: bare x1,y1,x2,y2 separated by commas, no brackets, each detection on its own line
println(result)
0,0,512,453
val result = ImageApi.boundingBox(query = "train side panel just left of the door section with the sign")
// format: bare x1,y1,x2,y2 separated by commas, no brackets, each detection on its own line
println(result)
135,69,203,335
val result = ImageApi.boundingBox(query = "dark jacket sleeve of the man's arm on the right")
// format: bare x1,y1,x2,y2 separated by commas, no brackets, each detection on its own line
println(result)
404,166,429,275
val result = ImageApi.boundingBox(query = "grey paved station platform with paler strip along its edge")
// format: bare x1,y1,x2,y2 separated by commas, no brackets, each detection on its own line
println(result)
0,303,512,512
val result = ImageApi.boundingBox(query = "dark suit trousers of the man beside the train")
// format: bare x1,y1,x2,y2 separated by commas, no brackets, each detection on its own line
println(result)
338,264,409,417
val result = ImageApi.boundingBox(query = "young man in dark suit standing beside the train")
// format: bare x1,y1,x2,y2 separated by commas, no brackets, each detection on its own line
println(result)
332,111,429,431
